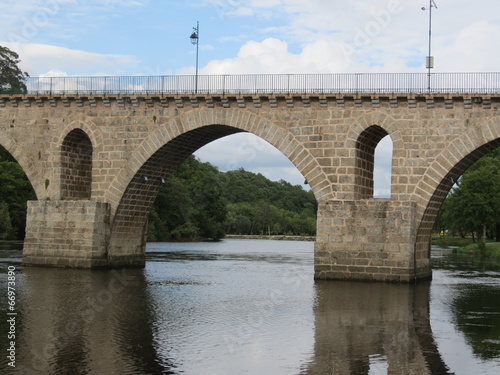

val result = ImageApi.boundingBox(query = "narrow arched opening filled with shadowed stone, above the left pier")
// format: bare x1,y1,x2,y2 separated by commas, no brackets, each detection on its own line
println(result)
61,129,93,200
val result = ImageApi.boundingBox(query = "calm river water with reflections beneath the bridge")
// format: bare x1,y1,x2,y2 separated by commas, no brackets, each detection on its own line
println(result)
0,239,500,375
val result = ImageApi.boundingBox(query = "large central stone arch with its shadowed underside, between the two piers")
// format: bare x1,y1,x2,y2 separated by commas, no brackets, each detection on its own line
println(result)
108,110,332,264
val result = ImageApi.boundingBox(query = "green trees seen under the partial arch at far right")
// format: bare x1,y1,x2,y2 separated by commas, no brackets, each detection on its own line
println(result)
437,149,500,240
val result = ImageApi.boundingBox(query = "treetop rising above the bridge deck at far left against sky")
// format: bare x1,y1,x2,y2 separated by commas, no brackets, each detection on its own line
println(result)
0,46,29,94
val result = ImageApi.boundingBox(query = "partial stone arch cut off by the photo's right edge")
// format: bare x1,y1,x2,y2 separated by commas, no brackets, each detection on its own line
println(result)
414,120,500,268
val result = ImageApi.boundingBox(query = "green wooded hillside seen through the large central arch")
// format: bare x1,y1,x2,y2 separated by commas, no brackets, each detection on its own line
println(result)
148,157,317,241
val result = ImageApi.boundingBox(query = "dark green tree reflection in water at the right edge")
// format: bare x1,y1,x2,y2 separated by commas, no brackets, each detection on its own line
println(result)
453,285,500,359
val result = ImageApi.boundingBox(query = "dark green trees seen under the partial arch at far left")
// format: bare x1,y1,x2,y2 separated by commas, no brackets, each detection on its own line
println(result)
0,147,36,240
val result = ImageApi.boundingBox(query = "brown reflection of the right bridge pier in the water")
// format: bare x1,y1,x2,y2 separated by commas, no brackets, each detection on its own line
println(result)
303,282,450,375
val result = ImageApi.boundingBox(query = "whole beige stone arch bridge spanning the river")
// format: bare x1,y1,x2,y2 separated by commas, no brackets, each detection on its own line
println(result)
0,93,500,282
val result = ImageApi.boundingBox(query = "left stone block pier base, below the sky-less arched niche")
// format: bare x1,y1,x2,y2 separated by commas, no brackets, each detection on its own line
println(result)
23,201,110,268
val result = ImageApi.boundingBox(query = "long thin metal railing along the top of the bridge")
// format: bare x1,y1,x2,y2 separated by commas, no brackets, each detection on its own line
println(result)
12,73,500,95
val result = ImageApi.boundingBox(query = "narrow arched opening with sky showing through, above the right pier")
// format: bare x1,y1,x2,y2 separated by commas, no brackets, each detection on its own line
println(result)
354,125,392,199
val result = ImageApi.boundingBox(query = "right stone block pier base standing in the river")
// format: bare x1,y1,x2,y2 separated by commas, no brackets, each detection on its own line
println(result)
314,199,431,283
